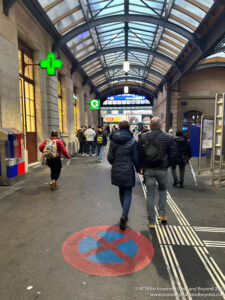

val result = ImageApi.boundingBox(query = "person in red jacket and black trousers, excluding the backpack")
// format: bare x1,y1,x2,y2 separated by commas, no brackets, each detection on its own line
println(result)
39,130,70,190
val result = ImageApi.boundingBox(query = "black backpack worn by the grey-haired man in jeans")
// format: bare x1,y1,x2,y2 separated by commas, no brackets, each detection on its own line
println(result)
144,132,163,167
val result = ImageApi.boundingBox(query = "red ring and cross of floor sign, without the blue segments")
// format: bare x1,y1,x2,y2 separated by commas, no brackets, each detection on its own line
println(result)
62,225,154,276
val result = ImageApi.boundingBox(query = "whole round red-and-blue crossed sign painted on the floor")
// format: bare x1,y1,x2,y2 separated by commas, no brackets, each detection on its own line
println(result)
62,225,154,276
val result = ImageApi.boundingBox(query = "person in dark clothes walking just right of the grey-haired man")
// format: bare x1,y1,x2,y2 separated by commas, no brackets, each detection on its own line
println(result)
171,130,192,188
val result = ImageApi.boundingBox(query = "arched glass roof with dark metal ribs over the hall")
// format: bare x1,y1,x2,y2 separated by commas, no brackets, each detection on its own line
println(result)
38,0,214,97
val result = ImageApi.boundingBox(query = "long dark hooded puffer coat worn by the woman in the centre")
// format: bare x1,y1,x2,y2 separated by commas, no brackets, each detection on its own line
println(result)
107,129,140,187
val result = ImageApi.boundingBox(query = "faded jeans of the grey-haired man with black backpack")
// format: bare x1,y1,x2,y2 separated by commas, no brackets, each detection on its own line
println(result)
144,169,167,224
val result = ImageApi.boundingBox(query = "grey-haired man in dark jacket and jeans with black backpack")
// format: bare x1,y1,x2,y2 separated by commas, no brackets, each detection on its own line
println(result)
138,117,176,229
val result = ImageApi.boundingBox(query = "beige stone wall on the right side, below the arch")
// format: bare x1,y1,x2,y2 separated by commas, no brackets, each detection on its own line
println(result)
153,68,225,131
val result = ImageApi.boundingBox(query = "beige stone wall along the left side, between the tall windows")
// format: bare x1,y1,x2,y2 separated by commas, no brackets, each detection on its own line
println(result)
0,0,98,162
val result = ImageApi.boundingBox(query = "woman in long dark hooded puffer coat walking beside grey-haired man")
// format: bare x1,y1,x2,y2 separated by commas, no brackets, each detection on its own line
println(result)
107,121,139,230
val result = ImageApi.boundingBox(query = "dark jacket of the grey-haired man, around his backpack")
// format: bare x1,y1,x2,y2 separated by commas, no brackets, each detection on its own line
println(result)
138,129,176,170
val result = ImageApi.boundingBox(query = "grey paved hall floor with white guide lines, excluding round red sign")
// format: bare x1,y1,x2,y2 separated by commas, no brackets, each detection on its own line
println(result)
0,152,225,300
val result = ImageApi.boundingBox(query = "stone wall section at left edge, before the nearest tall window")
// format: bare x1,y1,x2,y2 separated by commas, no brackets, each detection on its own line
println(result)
0,1,21,130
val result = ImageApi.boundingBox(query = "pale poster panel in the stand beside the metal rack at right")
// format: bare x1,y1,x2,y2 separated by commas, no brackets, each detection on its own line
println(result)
202,117,214,154
